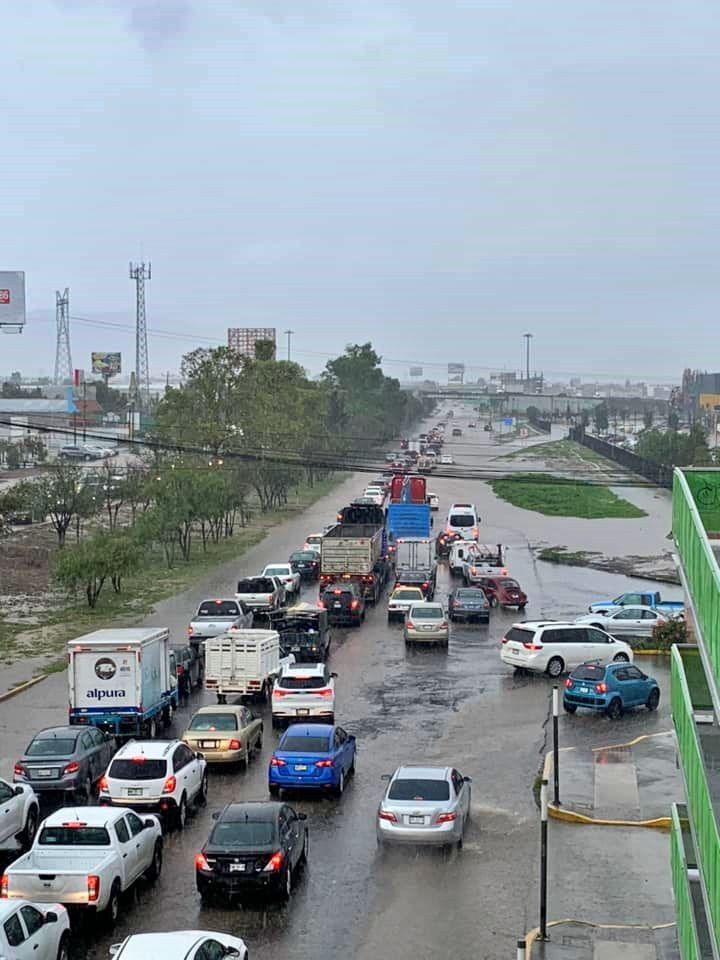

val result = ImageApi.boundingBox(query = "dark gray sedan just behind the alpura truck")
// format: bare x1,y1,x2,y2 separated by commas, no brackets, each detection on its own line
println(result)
13,727,116,802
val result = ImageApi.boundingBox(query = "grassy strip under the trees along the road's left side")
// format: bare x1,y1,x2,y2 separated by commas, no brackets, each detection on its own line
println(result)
0,474,346,673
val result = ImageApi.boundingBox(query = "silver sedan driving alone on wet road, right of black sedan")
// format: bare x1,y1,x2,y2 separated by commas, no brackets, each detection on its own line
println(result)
377,767,472,848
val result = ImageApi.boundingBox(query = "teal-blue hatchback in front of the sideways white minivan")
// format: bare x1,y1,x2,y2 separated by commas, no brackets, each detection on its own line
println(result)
563,662,660,720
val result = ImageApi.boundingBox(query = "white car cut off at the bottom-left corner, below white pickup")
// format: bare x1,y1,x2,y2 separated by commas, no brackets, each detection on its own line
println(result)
0,900,70,960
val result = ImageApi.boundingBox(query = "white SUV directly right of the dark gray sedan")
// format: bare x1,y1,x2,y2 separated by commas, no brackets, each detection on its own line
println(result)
99,740,208,828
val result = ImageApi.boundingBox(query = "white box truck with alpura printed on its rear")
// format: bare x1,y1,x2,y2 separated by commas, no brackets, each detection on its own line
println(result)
67,627,178,737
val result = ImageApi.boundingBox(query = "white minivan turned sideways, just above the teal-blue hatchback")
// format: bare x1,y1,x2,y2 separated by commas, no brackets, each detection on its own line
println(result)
500,620,633,677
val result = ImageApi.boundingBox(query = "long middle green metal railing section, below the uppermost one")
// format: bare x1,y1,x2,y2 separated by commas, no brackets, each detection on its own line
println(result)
671,647,720,944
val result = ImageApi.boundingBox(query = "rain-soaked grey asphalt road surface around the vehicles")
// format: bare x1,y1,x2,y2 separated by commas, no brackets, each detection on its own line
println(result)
0,420,672,960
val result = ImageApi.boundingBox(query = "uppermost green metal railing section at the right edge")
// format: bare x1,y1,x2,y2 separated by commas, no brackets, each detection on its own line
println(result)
672,469,720,685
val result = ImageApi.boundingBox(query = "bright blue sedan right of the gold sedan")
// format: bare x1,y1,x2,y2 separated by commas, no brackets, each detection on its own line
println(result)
268,723,356,797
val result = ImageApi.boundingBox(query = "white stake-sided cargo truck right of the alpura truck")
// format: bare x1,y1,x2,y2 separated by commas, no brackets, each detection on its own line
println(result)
205,630,295,703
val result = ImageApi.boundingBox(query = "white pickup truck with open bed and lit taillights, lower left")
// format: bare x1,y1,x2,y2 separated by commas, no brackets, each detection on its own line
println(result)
0,807,162,924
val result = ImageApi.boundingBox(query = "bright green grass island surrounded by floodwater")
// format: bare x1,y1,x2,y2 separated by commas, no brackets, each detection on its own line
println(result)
488,473,647,520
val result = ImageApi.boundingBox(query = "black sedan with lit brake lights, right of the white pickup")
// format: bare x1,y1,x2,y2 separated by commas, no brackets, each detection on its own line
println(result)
195,800,308,903
